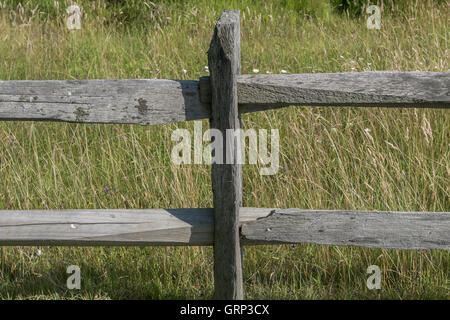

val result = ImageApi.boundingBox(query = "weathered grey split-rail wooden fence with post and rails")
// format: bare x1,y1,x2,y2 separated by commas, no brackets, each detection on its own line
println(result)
0,11,450,299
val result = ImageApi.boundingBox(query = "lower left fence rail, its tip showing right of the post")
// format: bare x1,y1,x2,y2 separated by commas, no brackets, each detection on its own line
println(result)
0,208,271,246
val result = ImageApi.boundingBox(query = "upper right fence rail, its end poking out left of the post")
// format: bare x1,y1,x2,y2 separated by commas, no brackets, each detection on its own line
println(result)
200,71,450,113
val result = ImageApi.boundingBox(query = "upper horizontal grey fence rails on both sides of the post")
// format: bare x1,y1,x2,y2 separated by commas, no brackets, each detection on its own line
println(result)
0,71,450,125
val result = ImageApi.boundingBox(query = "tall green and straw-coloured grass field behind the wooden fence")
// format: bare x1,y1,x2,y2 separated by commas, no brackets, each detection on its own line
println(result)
0,0,450,299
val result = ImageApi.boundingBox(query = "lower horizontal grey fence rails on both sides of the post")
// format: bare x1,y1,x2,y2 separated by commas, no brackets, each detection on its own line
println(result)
0,207,450,250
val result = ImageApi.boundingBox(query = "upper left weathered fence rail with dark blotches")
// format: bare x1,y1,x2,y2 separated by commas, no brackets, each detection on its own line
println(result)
0,79,210,125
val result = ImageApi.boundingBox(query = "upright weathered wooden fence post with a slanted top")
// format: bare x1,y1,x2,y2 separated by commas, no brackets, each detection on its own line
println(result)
208,10,243,300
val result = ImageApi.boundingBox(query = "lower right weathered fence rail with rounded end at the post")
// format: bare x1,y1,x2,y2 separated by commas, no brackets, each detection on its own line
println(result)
241,209,450,250
